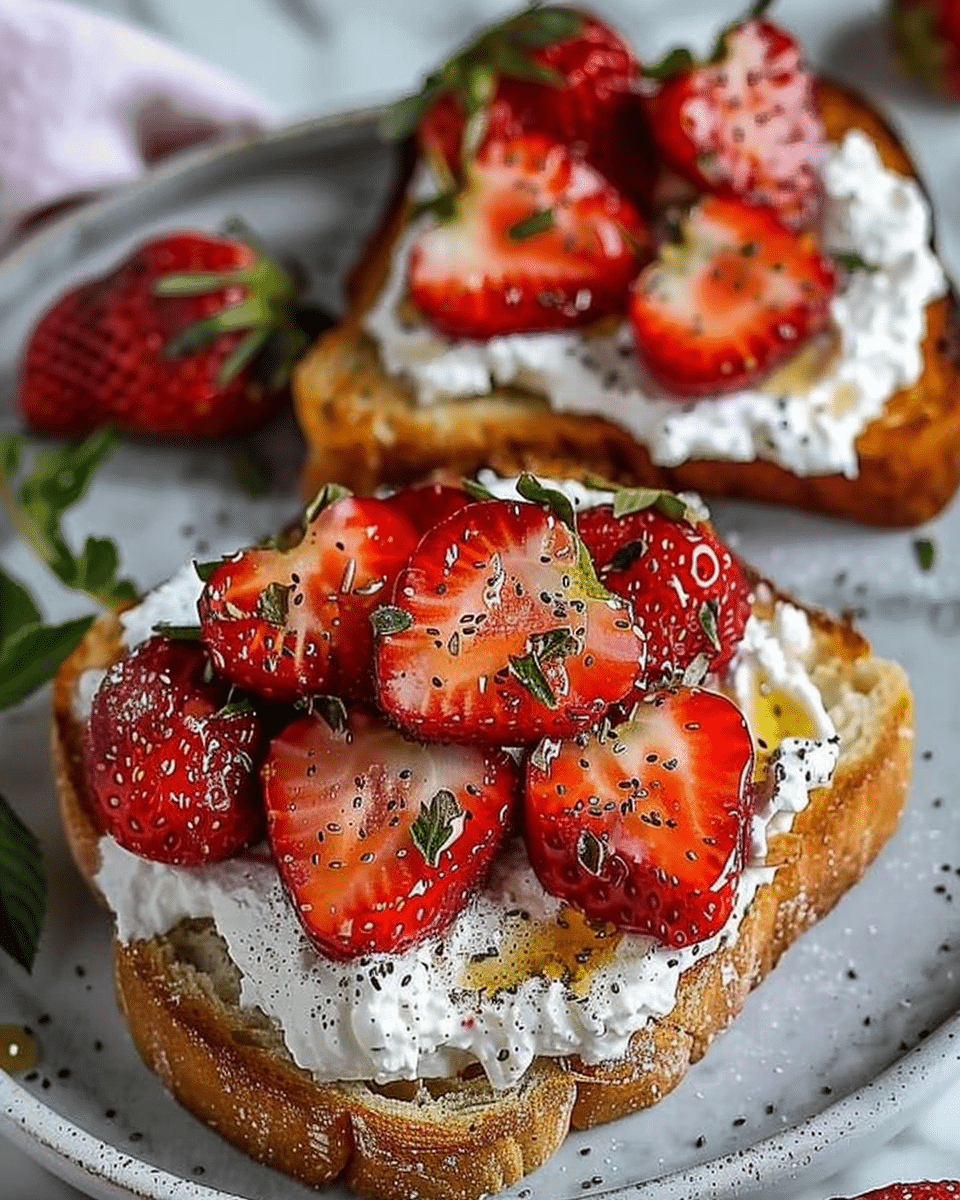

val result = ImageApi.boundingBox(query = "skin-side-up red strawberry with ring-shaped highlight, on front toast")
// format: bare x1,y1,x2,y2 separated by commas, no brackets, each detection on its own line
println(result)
577,491,750,684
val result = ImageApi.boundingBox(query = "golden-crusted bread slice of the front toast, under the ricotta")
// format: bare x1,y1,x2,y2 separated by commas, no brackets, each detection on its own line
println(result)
53,583,912,1200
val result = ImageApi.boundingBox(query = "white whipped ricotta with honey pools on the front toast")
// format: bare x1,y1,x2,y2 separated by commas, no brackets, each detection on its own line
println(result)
88,479,839,1087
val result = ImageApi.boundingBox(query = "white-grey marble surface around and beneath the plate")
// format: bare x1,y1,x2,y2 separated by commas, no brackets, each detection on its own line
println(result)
0,0,960,1200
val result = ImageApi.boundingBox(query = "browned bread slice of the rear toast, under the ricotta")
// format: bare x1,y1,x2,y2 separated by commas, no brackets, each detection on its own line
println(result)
293,80,960,526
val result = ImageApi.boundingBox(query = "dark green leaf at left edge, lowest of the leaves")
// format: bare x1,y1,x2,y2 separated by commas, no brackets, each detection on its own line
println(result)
0,796,47,971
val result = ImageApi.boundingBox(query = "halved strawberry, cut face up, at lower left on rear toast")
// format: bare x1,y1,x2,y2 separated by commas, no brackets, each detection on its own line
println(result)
408,134,649,338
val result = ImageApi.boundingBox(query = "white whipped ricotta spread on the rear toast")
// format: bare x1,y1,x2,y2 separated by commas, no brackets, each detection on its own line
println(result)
364,130,947,478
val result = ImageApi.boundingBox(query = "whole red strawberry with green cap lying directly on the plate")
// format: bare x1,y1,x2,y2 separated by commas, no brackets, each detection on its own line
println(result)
19,224,306,437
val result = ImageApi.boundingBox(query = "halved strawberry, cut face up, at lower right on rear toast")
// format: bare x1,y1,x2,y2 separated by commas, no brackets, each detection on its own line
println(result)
630,196,836,396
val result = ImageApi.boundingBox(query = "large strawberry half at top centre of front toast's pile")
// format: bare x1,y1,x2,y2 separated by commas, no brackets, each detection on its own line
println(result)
374,482,642,745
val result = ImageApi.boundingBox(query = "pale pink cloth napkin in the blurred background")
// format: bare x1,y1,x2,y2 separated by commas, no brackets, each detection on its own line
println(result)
0,0,274,240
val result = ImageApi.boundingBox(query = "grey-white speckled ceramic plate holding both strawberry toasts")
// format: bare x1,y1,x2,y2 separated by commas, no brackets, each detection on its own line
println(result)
0,4,960,1200
